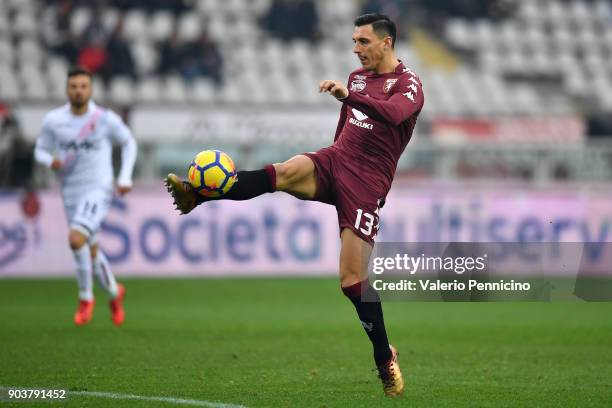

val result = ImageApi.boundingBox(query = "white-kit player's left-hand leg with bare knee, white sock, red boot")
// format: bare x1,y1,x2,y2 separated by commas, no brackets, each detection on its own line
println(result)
68,227,94,326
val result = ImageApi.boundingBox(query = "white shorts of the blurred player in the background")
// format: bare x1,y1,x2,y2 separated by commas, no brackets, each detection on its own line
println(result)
64,189,112,244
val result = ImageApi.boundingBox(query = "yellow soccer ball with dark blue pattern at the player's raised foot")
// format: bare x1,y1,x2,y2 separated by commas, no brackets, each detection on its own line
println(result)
187,150,237,197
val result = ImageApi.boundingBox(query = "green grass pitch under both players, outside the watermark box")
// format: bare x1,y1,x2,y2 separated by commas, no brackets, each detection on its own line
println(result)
0,278,612,407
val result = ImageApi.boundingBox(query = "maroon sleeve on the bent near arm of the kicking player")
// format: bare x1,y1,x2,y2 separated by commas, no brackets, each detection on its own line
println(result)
341,75,425,126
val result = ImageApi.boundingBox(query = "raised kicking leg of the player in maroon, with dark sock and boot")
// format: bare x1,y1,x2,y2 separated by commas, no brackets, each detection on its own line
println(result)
165,155,316,214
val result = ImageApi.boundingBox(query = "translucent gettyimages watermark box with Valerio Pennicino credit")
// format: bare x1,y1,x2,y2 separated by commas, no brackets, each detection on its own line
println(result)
363,243,612,301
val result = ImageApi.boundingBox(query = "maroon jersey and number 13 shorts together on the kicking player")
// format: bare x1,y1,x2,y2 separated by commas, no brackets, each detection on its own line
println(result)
305,63,424,245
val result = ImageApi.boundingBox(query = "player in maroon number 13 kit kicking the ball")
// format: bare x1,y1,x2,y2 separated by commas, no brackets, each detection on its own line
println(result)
166,14,424,396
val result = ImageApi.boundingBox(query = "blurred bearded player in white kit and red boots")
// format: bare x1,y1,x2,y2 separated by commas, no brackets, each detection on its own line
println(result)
34,67,137,326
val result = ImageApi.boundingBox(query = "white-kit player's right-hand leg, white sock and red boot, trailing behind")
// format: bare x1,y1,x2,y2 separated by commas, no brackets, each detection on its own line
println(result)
91,243,125,326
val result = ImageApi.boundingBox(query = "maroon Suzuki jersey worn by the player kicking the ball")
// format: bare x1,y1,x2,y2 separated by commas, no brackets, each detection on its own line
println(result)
332,62,425,193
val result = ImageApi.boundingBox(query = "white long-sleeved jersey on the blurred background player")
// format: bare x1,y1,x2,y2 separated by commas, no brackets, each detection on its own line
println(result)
35,101,137,198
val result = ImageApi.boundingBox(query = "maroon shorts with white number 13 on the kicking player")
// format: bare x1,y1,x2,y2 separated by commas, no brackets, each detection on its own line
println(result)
304,147,386,245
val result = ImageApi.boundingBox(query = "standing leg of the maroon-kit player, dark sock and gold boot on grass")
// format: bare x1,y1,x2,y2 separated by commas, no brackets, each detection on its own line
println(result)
340,228,404,396
